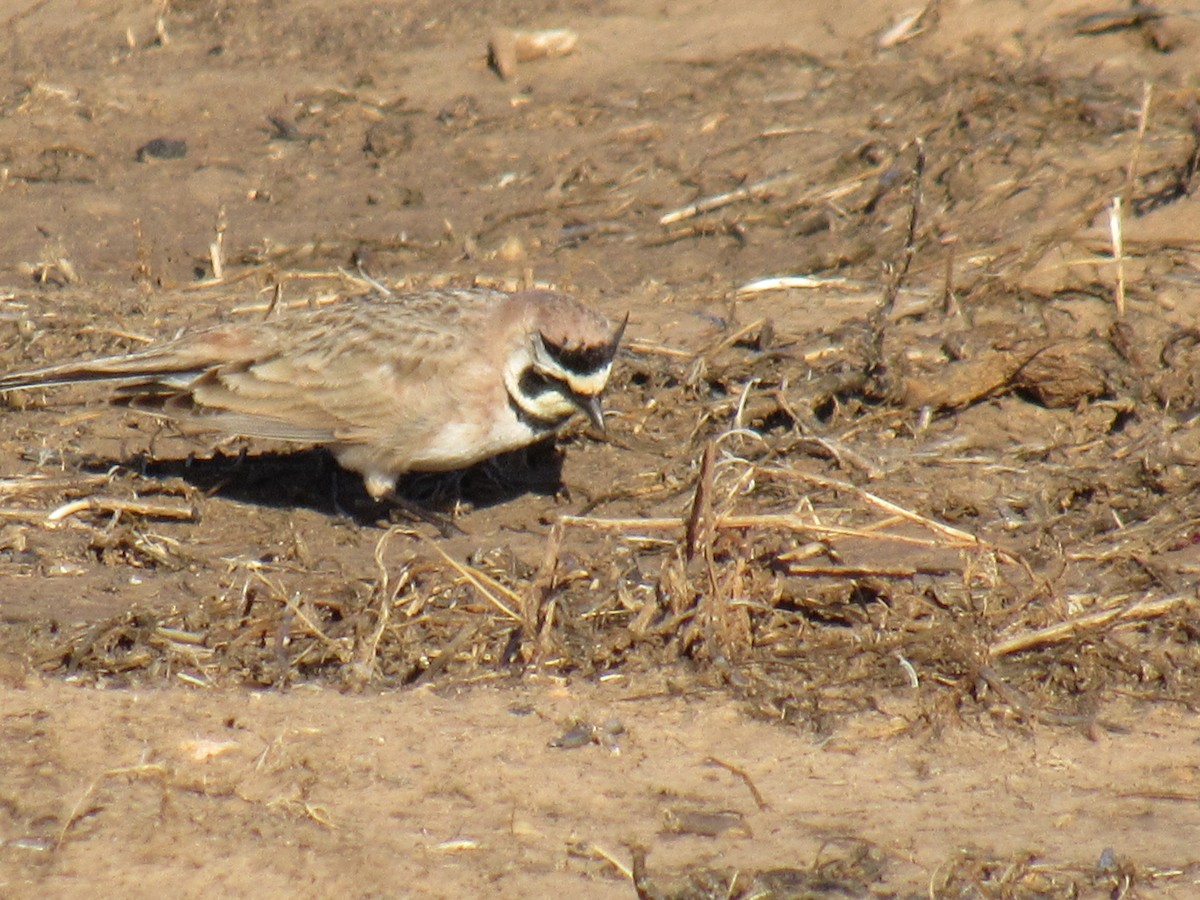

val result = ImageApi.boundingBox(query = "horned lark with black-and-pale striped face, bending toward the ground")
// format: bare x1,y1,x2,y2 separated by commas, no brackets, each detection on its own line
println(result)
0,288,628,499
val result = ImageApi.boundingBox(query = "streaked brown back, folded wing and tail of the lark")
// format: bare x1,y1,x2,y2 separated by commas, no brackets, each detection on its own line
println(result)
0,289,505,444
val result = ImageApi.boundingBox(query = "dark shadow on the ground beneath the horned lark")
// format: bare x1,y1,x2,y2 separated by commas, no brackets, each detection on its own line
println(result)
82,439,563,524
